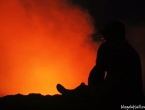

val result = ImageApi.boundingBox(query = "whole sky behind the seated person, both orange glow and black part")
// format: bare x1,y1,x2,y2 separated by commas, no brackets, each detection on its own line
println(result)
0,0,145,96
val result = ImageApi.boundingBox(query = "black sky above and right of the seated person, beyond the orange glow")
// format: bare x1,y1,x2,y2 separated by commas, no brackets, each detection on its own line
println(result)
71,0,145,91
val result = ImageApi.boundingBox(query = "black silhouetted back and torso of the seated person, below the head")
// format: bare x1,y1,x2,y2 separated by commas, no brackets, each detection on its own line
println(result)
102,40,143,100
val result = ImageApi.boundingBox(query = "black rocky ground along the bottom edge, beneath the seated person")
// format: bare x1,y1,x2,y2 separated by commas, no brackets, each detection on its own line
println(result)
0,94,145,110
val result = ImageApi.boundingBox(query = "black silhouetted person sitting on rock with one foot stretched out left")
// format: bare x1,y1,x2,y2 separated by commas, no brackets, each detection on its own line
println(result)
57,21,143,104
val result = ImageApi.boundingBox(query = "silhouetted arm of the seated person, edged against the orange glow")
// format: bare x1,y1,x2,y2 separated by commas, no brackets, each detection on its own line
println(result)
88,45,107,85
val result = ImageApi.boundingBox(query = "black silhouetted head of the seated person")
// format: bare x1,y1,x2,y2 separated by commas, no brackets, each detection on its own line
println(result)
101,21,125,41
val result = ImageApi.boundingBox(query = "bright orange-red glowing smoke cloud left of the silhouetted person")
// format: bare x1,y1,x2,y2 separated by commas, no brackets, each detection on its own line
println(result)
0,0,96,95
